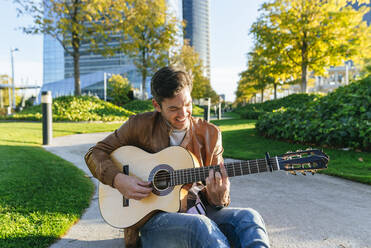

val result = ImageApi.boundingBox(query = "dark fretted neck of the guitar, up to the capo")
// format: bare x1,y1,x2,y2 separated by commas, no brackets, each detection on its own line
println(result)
170,157,279,186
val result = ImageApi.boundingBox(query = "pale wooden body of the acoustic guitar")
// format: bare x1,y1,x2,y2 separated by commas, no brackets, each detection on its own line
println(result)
99,146,199,228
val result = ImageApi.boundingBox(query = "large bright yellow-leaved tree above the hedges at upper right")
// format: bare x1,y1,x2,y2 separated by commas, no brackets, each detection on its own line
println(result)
251,0,371,92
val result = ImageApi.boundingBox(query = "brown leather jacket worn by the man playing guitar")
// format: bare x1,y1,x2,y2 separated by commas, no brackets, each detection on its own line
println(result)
85,111,223,189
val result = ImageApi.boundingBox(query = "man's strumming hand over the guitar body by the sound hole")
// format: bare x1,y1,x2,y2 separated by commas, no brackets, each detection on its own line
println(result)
113,173,152,200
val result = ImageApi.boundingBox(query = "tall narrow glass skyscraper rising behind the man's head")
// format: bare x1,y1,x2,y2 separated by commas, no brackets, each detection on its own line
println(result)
183,0,210,78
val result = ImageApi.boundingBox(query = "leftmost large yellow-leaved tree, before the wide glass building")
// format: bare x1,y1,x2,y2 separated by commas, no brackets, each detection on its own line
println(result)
14,0,112,96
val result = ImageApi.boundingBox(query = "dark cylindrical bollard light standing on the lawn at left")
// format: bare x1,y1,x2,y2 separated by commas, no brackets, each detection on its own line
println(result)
41,91,53,145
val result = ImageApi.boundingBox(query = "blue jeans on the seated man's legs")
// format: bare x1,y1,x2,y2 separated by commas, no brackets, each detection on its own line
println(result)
140,208,269,248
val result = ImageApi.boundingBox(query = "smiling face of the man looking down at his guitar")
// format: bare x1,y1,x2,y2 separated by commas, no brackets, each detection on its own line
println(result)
152,86,192,130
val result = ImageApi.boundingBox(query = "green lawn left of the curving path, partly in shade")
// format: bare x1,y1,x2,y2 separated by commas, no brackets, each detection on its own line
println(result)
0,122,121,248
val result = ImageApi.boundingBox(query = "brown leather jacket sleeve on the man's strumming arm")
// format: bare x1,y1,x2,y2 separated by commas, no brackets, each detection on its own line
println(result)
85,119,133,187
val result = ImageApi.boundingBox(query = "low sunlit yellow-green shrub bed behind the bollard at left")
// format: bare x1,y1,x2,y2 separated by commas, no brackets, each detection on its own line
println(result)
0,96,134,121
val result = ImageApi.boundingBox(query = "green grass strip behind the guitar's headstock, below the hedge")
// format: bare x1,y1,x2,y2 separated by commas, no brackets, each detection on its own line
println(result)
213,119,371,185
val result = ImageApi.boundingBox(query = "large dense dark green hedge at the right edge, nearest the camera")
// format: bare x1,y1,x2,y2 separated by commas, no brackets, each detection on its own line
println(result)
256,77,371,151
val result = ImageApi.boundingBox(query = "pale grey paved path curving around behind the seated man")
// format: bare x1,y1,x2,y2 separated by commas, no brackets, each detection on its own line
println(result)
45,133,371,248
